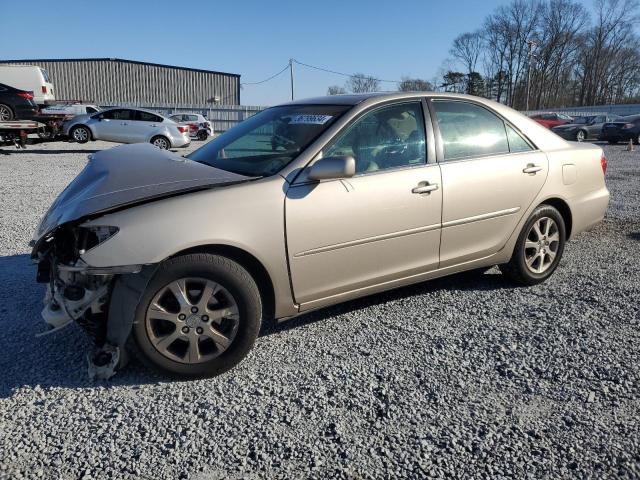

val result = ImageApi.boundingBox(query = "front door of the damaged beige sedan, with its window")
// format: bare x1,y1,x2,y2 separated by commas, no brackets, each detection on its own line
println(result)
285,101,442,310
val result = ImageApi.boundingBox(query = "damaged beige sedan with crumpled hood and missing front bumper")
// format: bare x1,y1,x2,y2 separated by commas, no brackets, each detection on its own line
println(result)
32,93,609,377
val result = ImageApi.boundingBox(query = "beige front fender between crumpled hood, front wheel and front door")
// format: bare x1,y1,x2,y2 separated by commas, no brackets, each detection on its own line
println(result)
81,176,297,316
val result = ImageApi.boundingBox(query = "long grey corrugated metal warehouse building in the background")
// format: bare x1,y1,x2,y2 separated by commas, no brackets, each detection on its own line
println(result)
0,58,240,107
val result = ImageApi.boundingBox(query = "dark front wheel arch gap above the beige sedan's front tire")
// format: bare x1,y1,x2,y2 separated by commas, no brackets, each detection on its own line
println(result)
169,244,275,320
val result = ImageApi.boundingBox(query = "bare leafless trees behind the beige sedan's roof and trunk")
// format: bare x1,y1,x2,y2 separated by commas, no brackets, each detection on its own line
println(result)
328,0,640,110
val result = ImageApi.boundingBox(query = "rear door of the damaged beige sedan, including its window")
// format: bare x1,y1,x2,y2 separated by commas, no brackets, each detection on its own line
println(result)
430,99,548,268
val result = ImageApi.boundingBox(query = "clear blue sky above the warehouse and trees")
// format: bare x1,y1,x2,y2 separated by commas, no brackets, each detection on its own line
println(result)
0,0,506,105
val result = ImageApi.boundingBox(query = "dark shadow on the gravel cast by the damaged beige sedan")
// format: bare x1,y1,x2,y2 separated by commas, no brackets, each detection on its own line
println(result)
0,255,513,398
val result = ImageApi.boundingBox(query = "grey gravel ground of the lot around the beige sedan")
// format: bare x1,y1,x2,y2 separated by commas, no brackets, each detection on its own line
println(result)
0,137,640,480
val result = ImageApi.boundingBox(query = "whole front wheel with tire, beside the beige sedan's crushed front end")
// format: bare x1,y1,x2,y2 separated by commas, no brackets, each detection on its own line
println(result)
133,254,262,377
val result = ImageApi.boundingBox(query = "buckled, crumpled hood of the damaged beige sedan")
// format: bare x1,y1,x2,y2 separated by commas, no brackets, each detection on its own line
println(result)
33,143,253,243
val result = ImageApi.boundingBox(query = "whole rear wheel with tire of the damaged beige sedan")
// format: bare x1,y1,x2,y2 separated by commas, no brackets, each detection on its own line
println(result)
500,205,566,285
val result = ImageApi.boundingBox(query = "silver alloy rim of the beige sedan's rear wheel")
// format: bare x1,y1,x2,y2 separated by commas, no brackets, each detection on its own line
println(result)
524,217,560,274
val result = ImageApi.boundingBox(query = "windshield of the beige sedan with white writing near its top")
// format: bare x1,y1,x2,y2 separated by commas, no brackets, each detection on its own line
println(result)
187,105,350,177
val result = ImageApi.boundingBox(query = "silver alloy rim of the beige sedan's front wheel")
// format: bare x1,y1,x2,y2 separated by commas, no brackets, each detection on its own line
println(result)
145,278,240,364
